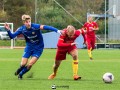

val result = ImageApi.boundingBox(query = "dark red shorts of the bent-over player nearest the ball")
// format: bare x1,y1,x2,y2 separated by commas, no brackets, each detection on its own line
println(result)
55,46,77,60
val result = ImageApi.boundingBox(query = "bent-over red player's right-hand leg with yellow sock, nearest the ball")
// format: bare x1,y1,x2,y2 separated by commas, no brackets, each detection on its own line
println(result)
70,49,81,80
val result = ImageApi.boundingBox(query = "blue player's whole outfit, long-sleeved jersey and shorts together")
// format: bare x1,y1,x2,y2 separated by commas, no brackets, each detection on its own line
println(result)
7,23,58,58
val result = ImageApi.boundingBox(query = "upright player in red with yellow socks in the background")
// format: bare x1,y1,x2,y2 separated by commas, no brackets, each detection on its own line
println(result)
83,16,99,60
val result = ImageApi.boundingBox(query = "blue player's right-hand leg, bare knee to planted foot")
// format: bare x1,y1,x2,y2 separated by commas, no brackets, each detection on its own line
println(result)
18,57,38,78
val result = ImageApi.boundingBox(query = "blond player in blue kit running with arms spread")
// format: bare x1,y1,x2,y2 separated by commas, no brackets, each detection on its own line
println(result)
4,14,60,79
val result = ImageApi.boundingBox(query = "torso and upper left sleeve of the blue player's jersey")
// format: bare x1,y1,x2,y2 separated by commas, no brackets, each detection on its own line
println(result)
14,23,44,47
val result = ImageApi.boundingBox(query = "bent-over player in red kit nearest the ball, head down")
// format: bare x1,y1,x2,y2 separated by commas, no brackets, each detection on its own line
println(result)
48,25,84,80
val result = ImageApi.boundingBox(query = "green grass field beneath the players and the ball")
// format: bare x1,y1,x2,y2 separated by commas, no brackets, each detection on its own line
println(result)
0,49,120,90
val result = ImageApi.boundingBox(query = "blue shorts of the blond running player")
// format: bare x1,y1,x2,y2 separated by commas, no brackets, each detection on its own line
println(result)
23,46,43,58
